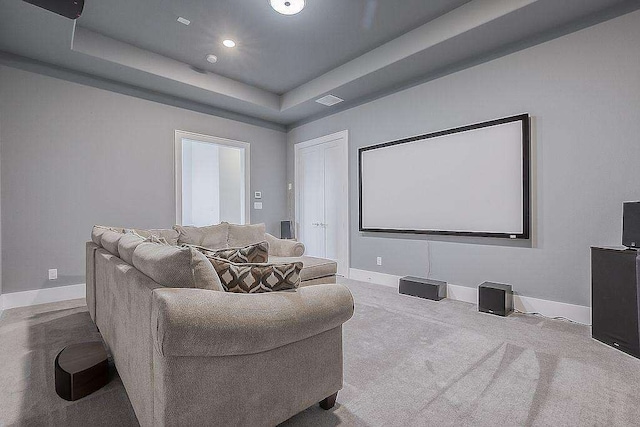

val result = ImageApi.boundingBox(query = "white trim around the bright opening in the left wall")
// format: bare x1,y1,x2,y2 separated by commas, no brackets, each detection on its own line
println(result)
173,129,251,225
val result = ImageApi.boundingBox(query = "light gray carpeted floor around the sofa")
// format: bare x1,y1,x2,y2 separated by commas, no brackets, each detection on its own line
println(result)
0,281,640,427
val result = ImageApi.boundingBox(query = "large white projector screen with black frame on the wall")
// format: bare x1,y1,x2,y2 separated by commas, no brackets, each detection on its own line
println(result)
358,114,529,239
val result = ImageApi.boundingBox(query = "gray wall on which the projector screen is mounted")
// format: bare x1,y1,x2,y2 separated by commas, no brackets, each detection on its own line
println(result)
288,12,640,305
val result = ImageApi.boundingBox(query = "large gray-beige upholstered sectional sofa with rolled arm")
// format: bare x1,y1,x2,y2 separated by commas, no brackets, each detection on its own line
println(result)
86,226,353,426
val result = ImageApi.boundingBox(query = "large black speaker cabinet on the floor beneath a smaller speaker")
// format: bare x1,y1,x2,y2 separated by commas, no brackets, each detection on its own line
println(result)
591,247,640,358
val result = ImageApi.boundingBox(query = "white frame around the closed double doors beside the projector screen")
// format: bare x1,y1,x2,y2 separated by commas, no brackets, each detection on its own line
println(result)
293,130,351,278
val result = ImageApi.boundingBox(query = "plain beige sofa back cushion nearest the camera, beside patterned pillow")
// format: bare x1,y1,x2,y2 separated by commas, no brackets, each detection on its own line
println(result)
132,242,224,291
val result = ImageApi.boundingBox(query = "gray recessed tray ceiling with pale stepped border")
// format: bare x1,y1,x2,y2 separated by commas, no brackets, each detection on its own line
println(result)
0,0,640,126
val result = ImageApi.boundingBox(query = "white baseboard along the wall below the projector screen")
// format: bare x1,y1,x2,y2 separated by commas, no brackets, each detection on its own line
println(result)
349,268,591,325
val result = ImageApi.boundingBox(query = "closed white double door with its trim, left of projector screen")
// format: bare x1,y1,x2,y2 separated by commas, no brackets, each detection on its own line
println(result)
295,131,349,277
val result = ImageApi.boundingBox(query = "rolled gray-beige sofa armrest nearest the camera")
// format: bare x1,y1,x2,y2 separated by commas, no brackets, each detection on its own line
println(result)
151,285,353,357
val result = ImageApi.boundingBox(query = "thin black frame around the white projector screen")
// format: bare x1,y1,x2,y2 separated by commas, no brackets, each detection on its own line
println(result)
358,113,531,240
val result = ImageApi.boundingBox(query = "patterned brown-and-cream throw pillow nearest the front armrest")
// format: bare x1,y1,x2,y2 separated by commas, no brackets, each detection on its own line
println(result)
207,257,302,294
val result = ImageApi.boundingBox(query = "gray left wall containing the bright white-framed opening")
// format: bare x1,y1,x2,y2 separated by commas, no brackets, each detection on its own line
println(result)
0,66,286,293
